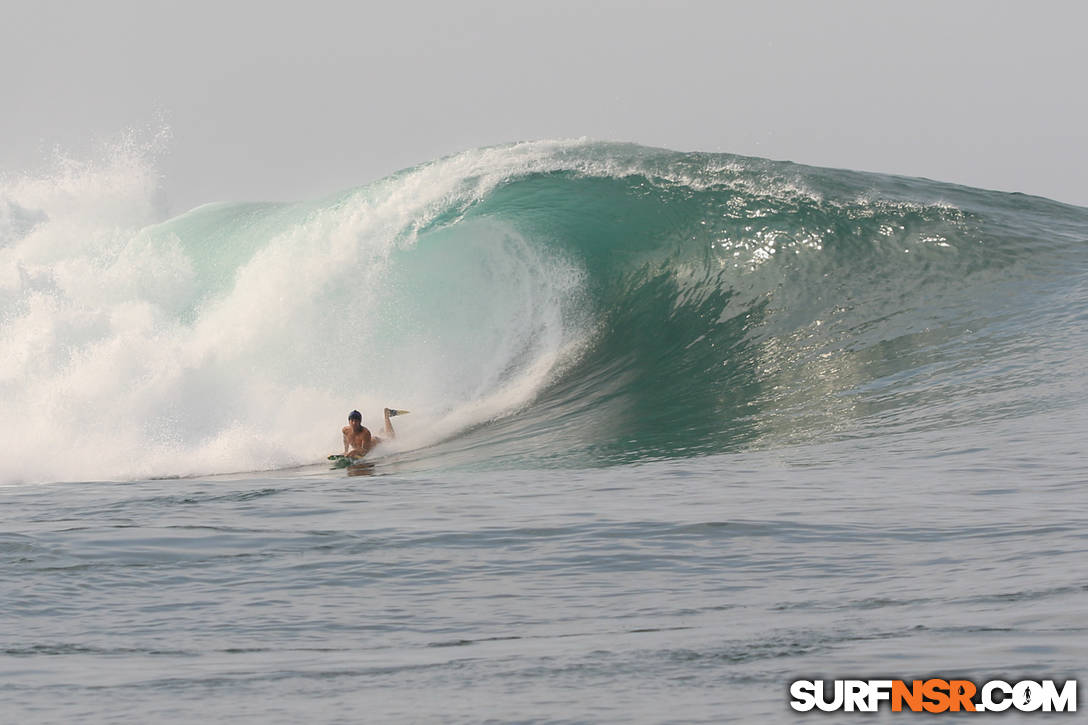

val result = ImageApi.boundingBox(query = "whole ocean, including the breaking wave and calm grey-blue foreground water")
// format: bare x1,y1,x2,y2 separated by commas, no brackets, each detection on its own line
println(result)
0,140,1088,723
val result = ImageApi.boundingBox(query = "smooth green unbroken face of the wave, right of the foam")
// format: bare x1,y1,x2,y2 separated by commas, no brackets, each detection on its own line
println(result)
398,146,1088,465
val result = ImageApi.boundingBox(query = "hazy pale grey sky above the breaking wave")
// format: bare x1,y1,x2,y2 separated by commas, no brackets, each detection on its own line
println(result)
0,0,1088,211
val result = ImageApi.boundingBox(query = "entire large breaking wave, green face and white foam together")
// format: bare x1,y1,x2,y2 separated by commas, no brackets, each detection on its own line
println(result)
0,140,1088,481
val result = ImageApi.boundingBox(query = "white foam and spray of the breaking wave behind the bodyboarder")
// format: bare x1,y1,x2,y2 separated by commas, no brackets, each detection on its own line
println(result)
0,132,596,482
